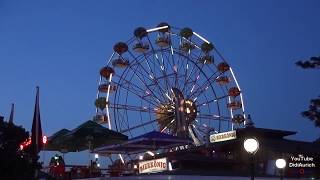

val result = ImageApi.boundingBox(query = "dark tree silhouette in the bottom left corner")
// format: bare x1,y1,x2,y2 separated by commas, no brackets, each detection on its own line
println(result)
0,121,39,179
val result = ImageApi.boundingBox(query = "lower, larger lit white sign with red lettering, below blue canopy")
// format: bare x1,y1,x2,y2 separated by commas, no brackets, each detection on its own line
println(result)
139,158,168,173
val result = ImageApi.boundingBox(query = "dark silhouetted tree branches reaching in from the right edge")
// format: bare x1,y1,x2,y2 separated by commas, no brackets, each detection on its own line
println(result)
296,56,320,128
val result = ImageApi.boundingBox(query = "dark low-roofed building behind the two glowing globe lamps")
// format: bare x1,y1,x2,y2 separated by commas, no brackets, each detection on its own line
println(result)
154,127,320,177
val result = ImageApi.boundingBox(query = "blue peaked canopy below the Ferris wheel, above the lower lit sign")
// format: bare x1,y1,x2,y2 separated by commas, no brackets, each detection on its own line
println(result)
94,131,192,154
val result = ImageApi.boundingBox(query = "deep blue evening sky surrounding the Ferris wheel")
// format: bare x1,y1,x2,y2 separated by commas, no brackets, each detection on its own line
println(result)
0,0,320,165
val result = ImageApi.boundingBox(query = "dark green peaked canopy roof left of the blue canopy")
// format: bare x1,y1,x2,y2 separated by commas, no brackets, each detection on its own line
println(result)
45,120,128,152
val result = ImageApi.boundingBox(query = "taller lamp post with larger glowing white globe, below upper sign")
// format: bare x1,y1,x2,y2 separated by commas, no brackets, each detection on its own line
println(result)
243,138,259,180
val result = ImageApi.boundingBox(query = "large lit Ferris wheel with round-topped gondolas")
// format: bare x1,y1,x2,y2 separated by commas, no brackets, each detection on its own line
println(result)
94,23,246,144
